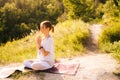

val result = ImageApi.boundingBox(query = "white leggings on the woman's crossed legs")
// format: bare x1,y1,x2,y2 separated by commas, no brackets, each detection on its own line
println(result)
24,59,52,70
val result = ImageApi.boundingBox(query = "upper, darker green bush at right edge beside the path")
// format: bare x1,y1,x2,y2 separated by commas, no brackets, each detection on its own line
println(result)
99,22,120,43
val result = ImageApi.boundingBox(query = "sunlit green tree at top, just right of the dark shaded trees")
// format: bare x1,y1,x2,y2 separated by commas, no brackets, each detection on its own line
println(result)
63,0,103,22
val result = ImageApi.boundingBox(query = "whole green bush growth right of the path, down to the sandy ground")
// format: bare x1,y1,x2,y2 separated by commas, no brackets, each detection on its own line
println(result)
99,22,120,61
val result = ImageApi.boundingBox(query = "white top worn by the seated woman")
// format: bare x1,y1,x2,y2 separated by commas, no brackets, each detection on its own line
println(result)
37,36,54,67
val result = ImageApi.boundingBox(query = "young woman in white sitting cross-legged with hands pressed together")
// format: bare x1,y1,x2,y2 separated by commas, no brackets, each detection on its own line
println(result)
24,21,54,70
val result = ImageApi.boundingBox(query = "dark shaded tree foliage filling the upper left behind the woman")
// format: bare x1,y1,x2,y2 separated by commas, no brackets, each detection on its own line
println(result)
0,0,63,43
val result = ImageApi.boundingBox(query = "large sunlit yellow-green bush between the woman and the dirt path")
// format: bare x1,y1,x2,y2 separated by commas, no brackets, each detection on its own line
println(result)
55,20,89,57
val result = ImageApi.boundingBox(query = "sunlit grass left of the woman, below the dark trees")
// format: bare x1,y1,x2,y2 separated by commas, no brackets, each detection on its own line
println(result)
0,36,36,64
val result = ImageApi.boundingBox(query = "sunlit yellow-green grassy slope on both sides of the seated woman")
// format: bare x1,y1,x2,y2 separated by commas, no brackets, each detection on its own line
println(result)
0,20,89,65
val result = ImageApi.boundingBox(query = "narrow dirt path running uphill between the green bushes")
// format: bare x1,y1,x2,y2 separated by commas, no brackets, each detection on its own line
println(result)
86,24,104,53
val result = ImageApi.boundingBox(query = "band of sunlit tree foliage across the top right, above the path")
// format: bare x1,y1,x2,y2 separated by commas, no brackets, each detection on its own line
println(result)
63,0,120,22
